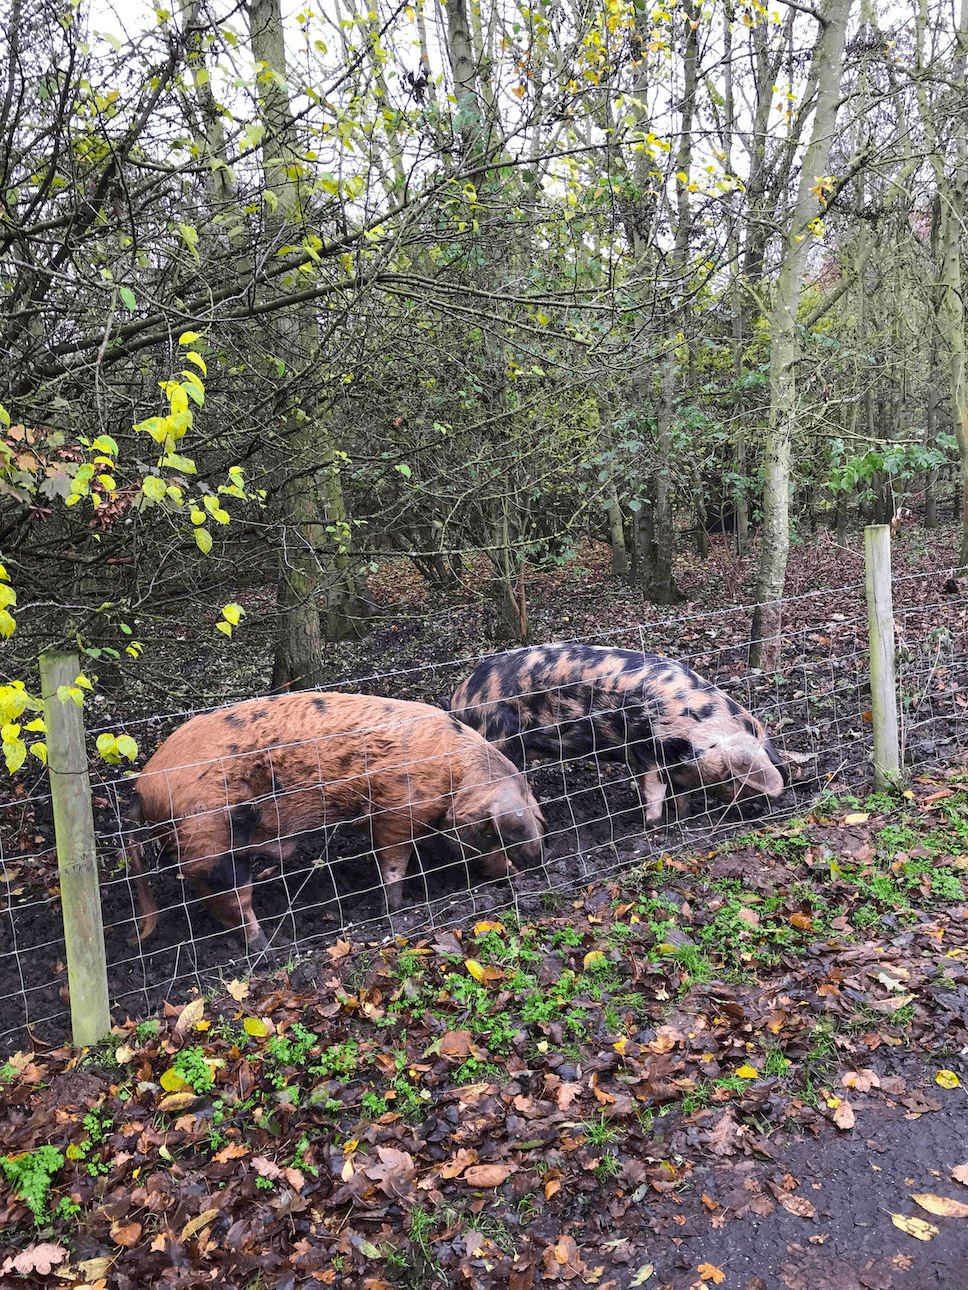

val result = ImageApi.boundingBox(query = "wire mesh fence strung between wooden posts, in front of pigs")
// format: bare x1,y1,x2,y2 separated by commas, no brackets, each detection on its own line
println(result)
0,559,968,1051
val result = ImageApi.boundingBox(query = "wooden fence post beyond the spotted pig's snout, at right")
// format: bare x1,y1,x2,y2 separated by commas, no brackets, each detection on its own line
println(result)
863,524,901,788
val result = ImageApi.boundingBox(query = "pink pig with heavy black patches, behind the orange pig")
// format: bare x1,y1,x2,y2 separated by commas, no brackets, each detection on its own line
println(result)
445,644,790,823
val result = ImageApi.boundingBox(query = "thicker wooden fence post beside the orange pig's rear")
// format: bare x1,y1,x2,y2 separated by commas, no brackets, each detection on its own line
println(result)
40,650,111,1047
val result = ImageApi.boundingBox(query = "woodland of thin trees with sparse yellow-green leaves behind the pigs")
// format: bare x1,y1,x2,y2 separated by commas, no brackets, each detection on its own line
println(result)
0,0,968,769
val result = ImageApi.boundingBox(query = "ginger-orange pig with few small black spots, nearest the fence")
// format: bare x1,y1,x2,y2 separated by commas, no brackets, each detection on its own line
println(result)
126,691,545,949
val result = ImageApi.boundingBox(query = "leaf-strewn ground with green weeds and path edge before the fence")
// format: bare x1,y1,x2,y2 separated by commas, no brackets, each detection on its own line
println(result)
0,766,968,1290
